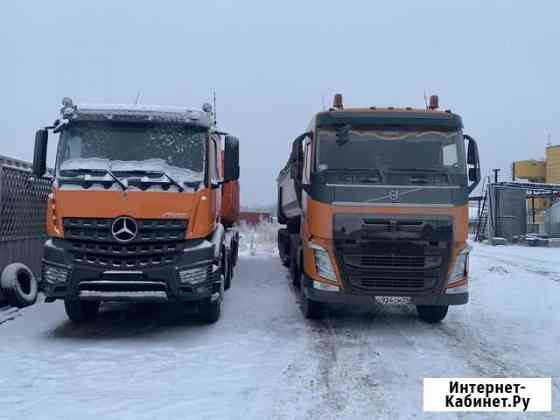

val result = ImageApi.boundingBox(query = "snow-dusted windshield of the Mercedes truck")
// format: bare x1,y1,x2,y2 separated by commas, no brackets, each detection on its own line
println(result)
57,122,206,183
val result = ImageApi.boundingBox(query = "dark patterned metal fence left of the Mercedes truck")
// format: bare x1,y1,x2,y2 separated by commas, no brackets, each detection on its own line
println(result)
0,155,51,275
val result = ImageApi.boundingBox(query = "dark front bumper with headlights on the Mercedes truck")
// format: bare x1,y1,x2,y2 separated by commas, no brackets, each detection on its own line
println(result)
40,239,222,302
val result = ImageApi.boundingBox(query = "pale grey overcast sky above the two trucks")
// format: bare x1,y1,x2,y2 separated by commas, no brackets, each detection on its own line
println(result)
0,0,560,205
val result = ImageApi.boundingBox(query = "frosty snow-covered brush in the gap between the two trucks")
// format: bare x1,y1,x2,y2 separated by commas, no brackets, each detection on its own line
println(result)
239,220,282,255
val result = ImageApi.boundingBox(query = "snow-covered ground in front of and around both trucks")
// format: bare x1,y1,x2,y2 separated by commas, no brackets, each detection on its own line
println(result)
0,245,560,419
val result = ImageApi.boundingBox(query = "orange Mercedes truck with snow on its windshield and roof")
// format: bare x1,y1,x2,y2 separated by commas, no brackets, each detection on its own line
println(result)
33,98,239,322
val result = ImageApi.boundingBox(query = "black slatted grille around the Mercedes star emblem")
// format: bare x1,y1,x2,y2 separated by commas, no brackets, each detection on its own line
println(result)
64,218,187,269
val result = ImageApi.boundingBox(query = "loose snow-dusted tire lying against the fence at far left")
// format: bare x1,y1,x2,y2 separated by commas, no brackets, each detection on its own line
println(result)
0,263,37,308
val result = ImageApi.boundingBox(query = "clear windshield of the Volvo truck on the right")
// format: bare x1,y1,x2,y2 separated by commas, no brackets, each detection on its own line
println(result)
316,127,466,184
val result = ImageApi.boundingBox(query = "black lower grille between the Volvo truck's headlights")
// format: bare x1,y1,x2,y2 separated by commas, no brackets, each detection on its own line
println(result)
335,240,443,293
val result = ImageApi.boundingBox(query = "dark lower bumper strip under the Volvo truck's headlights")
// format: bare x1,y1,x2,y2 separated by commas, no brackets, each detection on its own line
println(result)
303,275,469,305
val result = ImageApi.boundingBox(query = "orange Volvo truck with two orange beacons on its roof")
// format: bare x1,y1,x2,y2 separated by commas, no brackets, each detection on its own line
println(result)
277,95,480,322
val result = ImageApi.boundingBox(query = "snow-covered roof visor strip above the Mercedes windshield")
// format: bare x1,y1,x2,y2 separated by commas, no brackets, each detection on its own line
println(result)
60,98,213,127
